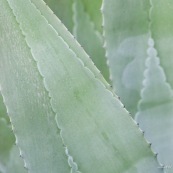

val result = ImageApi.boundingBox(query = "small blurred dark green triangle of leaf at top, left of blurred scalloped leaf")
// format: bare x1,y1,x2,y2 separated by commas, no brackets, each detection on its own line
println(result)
44,0,74,33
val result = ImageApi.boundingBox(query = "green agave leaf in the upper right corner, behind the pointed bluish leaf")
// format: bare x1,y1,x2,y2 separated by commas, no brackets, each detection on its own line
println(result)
150,0,173,91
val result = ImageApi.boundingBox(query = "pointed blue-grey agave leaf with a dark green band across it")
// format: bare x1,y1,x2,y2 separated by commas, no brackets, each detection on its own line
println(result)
136,39,173,172
